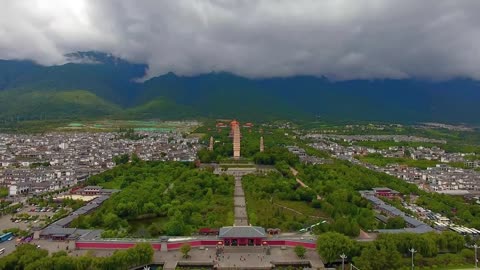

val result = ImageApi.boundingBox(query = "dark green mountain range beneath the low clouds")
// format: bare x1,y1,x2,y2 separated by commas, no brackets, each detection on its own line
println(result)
0,52,480,124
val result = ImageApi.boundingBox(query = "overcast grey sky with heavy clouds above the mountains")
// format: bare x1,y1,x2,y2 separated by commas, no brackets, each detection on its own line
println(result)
0,0,480,80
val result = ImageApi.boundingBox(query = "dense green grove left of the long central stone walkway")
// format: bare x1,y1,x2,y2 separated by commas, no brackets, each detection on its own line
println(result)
72,161,234,237
